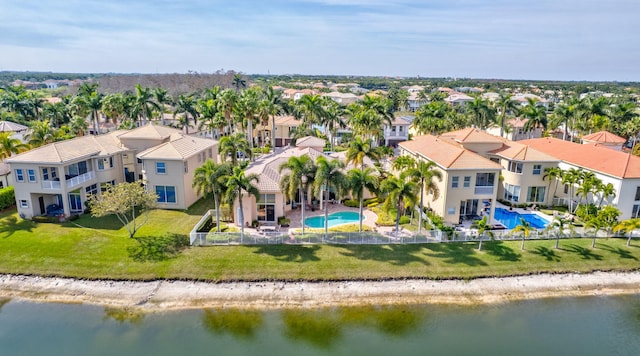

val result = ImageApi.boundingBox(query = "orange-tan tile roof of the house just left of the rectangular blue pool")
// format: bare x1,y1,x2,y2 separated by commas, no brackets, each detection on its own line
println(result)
400,135,502,170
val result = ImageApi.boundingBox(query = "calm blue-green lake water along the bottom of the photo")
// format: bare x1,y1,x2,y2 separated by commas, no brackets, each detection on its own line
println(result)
0,296,640,356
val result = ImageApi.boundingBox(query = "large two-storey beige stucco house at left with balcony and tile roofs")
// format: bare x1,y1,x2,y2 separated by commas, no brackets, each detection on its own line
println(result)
6,124,217,218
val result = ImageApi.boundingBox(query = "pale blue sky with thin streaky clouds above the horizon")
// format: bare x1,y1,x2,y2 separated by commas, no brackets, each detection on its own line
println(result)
0,0,640,81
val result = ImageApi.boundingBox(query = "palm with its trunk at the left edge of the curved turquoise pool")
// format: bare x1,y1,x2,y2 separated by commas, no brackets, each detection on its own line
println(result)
278,155,316,235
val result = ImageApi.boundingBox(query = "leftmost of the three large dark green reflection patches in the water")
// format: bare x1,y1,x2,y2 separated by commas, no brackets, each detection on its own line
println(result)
202,308,264,339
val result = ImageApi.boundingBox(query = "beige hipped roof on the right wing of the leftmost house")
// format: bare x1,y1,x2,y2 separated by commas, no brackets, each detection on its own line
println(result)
136,134,218,161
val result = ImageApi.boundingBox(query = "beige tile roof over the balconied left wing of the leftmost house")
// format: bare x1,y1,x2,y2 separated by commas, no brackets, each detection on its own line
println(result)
6,133,128,164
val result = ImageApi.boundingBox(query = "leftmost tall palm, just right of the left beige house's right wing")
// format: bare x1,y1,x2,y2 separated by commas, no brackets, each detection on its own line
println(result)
192,159,231,232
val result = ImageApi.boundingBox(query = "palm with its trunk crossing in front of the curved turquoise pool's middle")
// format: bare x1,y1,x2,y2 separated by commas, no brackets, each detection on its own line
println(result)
314,156,346,238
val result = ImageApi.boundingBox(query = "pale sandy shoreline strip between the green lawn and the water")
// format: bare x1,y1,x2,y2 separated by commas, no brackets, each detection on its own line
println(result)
0,272,640,311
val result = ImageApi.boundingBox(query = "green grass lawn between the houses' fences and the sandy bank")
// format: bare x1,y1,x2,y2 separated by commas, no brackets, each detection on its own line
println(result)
0,202,640,281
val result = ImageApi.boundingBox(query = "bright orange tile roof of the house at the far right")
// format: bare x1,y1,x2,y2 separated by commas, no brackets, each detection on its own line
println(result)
519,137,640,178
